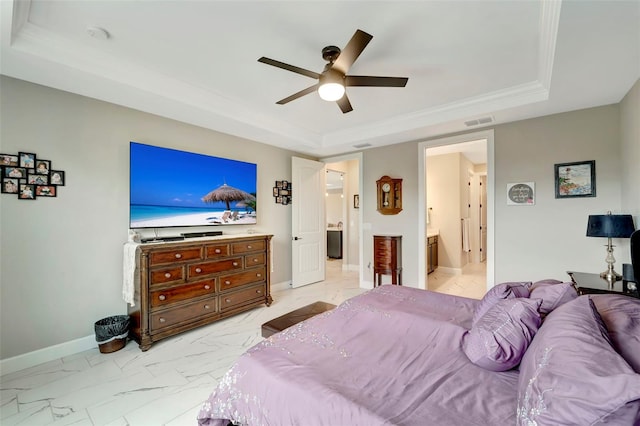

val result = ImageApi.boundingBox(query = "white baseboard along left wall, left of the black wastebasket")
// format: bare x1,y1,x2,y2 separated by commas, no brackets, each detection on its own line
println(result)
0,334,98,375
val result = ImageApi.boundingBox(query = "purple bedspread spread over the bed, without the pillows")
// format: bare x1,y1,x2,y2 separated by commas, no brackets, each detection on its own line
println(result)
198,285,517,426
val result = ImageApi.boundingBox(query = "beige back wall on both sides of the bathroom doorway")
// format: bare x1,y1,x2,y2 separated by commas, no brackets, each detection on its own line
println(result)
363,105,638,287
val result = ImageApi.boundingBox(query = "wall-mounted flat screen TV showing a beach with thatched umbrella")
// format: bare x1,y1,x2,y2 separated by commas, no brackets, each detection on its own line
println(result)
129,142,258,228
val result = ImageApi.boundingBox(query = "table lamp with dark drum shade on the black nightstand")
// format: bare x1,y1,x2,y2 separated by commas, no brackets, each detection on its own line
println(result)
587,212,635,288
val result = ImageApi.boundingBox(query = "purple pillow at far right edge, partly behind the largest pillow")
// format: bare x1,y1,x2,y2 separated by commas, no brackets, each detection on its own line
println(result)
591,294,640,374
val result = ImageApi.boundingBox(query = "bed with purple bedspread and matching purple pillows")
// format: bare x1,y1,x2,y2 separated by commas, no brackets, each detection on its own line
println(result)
198,280,640,426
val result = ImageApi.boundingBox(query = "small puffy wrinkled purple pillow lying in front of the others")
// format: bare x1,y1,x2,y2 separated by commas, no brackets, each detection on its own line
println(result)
462,298,541,371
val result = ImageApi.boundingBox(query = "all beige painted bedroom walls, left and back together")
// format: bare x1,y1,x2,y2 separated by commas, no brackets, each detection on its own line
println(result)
0,76,640,360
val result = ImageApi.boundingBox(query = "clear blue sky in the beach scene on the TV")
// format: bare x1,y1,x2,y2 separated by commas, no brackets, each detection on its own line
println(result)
129,142,257,208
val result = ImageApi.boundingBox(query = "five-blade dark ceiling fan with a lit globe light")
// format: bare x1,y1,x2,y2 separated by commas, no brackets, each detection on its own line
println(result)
258,30,409,114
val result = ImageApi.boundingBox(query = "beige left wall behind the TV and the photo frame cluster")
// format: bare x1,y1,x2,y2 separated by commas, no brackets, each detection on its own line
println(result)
0,76,300,360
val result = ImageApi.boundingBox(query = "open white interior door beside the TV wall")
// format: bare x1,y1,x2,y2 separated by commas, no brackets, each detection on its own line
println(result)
291,157,327,287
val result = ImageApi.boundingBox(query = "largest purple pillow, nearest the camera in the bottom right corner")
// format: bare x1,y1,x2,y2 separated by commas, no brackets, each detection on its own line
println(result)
517,295,640,425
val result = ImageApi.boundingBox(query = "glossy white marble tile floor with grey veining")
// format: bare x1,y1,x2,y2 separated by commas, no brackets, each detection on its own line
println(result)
0,261,484,426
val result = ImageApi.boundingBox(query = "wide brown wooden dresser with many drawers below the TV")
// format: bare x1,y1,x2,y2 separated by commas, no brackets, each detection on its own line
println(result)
129,234,273,351
